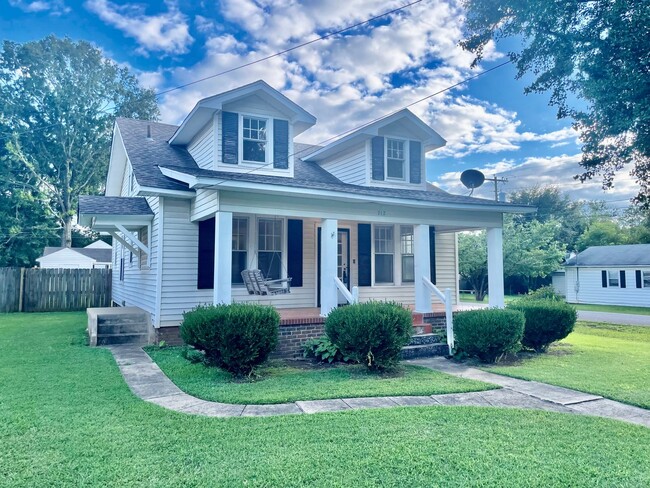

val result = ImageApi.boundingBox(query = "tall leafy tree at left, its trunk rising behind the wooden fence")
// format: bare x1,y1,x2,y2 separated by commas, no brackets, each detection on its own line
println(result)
0,36,159,247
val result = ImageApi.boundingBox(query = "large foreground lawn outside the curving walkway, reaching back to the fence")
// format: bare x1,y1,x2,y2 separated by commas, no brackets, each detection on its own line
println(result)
0,313,650,487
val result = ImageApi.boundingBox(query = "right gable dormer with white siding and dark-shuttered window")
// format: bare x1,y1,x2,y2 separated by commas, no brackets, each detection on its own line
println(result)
305,109,446,190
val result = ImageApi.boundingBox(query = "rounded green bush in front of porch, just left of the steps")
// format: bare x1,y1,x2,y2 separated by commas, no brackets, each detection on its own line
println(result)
325,302,413,370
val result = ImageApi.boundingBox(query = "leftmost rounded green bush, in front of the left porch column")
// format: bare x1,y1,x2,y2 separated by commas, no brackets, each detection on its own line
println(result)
181,303,280,375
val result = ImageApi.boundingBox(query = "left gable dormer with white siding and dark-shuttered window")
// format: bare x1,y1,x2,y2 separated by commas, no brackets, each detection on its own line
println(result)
169,81,316,177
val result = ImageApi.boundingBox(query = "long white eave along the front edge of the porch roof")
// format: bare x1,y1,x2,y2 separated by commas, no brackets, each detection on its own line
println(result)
160,168,536,213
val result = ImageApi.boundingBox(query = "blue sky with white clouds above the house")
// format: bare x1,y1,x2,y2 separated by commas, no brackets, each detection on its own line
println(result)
0,0,635,207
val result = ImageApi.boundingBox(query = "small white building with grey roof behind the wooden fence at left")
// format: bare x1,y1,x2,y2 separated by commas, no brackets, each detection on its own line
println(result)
36,241,113,269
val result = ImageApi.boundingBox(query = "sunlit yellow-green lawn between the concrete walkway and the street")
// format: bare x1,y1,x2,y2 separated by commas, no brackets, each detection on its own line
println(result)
489,322,650,408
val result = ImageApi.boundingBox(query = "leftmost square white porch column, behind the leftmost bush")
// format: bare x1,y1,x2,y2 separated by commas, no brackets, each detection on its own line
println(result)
214,212,232,305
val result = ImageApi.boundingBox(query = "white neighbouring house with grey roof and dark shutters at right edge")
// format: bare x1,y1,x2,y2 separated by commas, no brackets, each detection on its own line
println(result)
564,244,650,307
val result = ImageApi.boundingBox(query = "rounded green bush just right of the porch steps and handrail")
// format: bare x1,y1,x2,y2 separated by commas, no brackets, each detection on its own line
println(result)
454,308,524,363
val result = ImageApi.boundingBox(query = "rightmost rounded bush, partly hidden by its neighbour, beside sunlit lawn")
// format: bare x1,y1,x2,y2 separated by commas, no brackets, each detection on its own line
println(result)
508,300,578,352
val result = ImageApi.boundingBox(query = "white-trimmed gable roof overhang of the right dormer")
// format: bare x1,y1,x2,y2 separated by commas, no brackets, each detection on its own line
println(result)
303,108,447,162
